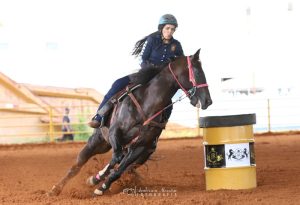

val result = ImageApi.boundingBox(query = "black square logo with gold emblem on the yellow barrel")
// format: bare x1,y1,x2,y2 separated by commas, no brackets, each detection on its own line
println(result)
205,145,225,168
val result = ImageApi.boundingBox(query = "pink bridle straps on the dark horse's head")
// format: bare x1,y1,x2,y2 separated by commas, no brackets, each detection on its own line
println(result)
169,56,208,98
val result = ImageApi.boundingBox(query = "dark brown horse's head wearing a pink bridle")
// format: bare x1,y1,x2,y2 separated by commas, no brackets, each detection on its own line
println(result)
170,49,212,110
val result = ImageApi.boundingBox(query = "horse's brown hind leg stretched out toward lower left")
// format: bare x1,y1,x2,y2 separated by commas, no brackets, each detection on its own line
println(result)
48,129,111,196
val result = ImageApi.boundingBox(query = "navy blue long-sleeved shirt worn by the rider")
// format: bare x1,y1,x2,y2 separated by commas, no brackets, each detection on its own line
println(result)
141,34,184,68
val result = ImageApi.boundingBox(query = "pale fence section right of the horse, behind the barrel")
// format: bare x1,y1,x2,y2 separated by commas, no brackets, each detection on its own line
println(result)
197,95,300,133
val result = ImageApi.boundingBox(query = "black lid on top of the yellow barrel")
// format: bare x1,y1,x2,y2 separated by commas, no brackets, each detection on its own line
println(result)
200,113,256,128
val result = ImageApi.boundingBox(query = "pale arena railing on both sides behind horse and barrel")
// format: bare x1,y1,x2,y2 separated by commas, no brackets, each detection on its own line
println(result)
0,96,300,144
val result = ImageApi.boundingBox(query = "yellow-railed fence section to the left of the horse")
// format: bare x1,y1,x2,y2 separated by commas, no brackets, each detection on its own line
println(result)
0,105,97,144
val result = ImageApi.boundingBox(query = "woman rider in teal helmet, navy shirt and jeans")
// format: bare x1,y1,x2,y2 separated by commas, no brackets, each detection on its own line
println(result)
89,14,184,128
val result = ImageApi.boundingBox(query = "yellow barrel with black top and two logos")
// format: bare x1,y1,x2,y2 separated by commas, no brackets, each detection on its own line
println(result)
200,114,256,190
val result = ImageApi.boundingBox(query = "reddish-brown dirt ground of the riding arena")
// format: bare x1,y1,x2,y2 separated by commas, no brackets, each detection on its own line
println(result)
0,134,300,205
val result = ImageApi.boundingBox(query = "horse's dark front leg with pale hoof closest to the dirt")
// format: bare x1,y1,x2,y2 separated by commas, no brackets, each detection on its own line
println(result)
94,146,146,196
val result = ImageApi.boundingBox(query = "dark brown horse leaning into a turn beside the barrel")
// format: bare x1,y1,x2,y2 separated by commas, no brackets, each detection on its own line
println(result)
48,49,212,196
